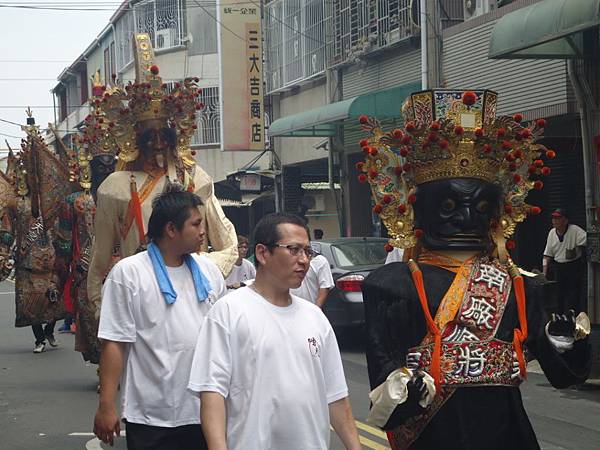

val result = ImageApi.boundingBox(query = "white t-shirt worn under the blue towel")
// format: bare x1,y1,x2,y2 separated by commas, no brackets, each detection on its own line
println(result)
98,252,225,427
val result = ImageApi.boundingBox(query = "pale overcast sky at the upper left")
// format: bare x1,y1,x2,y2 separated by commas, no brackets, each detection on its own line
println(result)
0,0,114,148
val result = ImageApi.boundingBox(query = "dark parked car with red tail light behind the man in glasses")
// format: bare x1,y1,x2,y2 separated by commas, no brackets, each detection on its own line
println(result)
311,237,387,328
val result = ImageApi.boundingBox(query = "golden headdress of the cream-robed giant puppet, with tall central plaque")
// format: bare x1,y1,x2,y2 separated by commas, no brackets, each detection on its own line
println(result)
84,34,204,170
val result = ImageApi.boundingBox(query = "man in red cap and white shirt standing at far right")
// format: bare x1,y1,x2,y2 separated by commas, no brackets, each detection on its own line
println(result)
542,208,587,313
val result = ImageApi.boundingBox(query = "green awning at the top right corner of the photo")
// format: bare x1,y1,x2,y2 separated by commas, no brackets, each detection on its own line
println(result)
488,0,600,59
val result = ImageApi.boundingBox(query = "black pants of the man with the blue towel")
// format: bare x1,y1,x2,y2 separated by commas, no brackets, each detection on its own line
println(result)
125,422,208,450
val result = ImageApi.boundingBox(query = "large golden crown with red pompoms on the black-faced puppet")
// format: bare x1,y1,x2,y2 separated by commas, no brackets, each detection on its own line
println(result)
357,90,555,250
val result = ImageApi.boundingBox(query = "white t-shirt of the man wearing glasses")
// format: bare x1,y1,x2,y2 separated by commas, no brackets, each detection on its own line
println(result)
189,287,348,450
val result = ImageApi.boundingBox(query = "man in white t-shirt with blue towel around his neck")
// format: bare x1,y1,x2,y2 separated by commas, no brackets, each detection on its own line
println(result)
94,185,225,450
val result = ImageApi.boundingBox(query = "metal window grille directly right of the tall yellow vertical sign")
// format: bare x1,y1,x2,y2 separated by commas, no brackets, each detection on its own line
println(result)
264,0,329,92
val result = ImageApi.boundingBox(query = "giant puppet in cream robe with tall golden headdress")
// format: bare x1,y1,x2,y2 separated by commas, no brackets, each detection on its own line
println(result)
86,34,237,311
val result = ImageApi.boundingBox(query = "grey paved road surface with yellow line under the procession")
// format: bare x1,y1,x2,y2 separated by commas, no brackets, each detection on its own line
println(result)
0,282,600,450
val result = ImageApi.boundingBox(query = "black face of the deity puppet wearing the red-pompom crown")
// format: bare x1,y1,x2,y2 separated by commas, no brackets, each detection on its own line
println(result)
414,178,502,251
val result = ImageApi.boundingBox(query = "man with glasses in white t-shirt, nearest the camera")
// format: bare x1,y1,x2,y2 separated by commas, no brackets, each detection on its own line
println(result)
189,214,360,450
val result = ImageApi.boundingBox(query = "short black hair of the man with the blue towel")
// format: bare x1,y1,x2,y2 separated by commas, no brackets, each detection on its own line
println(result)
147,182,203,241
